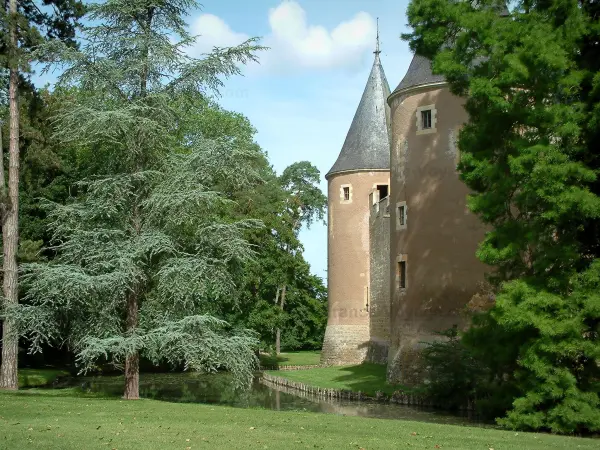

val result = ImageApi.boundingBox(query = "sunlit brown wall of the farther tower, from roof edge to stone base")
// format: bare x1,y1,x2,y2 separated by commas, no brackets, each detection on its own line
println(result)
321,170,389,365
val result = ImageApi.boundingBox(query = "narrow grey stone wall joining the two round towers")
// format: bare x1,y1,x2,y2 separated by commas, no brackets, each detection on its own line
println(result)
367,191,390,364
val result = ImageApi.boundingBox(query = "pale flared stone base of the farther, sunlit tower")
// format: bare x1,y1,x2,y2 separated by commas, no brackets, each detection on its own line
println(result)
321,325,370,366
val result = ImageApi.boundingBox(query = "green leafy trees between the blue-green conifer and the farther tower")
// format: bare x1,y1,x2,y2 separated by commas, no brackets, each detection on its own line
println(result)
159,96,327,356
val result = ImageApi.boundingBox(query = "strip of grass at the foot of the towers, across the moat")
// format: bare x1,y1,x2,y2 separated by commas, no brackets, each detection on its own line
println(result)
268,363,410,396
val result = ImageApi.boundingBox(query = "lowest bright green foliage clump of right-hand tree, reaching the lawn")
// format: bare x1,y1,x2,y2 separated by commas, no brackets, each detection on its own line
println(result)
492,260,600,433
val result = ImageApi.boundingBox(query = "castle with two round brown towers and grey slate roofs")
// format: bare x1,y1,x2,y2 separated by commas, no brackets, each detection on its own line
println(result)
321,33,486,385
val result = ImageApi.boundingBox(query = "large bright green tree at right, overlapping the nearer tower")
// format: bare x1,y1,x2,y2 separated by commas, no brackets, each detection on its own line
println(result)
403,0,600,433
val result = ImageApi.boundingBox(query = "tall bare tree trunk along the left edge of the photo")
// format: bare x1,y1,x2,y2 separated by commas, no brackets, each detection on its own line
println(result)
0,0,19,389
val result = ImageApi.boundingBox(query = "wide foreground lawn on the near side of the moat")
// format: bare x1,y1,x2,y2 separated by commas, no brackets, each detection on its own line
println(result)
0,389,600,450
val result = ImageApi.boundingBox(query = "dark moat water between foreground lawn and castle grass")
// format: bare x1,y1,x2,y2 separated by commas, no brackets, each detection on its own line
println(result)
59,373,488,426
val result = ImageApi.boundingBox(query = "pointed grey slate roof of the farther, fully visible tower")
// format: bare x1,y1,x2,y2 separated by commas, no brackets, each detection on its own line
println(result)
325,50,390,178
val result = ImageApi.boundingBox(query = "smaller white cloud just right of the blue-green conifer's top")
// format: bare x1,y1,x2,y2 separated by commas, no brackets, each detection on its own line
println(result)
191,14,249,56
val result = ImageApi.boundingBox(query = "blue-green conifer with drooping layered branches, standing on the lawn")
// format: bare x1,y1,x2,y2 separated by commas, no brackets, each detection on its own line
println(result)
13,0,261,399
